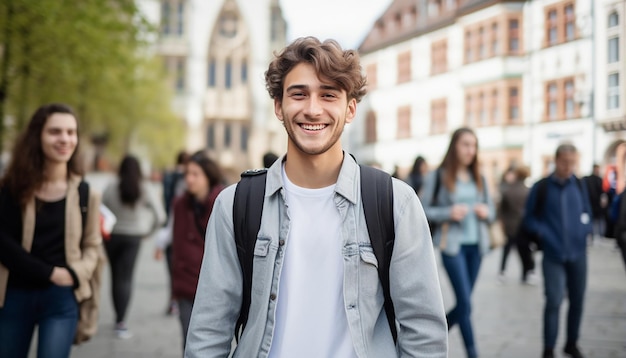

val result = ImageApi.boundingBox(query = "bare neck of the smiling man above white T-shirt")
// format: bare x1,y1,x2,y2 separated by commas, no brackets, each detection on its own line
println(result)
285,147,343,189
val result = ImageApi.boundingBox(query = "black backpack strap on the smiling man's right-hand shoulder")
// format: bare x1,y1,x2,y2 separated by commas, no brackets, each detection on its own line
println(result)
359,165,398,342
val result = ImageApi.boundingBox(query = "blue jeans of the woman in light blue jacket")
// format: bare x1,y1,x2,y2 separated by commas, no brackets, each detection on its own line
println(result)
441,245,481,357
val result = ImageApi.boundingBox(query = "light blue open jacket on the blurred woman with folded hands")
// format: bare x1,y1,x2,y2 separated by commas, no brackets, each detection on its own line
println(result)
420,170,496,255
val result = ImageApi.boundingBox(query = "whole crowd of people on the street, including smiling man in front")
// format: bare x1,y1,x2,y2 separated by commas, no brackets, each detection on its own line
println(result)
0,37,626,358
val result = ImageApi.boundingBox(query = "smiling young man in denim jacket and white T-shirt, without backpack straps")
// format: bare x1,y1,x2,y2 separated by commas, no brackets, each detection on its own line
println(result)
185,37,447,358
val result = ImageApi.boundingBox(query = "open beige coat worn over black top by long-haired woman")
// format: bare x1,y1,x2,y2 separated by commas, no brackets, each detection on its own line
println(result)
0,175,102,307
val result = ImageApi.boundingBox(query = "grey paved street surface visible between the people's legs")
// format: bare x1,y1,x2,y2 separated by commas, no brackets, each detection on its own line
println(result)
64,234,626,358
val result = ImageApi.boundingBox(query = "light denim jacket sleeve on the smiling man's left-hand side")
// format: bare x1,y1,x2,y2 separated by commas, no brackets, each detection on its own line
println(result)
185,185,242,358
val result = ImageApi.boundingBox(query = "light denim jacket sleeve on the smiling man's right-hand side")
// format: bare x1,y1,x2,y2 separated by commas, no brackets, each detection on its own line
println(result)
389,180,448,357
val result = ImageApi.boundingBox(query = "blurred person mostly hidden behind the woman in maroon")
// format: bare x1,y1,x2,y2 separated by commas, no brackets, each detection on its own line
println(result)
158,151,189,315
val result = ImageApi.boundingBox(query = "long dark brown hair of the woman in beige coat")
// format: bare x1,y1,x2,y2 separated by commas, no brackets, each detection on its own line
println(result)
0,103,83,206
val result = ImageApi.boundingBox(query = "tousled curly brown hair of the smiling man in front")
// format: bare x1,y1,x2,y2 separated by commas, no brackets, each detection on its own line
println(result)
265,36,367,102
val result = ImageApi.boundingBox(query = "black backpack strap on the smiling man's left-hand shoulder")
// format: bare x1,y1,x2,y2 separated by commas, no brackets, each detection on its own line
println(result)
233,169,267,341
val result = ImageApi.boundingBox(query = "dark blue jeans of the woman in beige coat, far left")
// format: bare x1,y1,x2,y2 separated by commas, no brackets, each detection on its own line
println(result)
0,285,78,358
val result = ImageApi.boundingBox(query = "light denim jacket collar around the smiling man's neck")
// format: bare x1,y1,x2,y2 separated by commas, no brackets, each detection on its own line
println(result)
265,151,359,204
